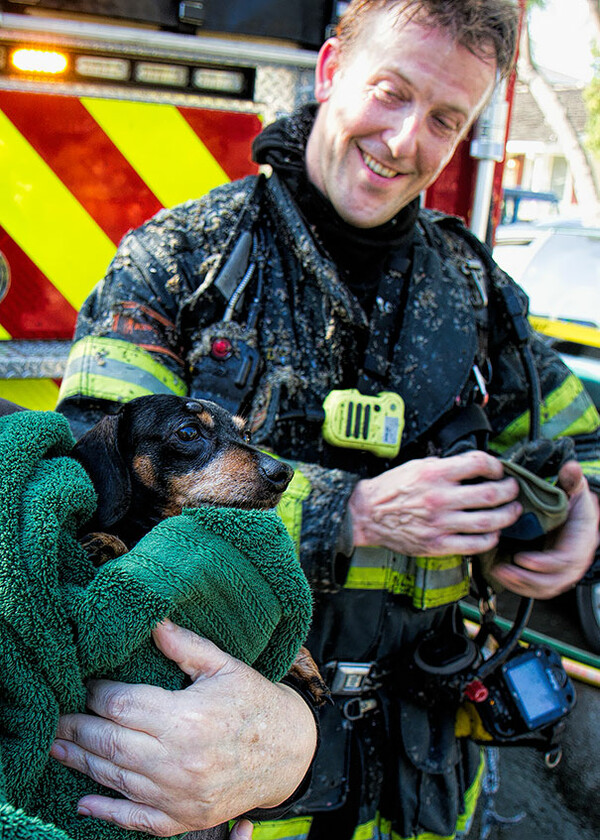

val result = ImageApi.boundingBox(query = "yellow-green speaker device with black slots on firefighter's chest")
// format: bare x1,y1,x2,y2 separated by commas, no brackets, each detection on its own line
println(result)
322,388,404,458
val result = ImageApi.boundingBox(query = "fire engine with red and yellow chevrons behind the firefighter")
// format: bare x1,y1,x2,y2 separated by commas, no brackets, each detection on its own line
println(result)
0,0,524,409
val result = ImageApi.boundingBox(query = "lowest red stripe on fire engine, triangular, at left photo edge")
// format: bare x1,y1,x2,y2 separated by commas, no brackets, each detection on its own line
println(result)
0,226,76,339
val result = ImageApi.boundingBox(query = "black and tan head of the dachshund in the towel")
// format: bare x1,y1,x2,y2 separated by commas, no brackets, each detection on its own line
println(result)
73,394,293,543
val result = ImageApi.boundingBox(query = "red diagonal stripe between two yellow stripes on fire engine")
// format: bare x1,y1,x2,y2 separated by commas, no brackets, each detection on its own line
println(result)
0,91,162,244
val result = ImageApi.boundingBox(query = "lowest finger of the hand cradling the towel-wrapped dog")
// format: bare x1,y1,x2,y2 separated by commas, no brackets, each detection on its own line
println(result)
77,796,188,840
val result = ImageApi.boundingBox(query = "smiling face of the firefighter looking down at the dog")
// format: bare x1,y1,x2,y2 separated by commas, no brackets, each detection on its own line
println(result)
306,9,496,228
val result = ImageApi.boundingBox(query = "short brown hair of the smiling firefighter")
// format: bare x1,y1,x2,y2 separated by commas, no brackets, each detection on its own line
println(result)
336,0,519,77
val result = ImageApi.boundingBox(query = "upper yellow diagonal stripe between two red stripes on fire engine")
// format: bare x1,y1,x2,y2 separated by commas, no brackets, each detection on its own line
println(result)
81,98,229,207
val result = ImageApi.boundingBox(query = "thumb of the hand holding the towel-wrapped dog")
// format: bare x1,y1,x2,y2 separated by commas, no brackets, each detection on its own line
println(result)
152,618,242,681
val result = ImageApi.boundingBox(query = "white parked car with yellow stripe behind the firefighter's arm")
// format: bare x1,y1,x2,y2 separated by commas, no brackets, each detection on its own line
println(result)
494,225,600,653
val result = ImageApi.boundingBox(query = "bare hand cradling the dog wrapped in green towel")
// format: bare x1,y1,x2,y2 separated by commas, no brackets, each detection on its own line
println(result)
51,621,316,840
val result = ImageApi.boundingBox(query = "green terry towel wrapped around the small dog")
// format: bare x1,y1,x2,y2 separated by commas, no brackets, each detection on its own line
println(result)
0,411,311,840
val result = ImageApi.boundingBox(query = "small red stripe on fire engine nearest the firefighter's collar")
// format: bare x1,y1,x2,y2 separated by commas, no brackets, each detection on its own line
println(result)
179,108,262,181
